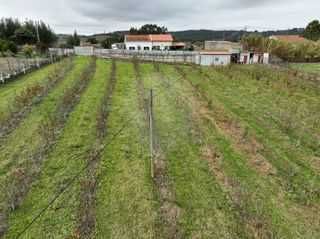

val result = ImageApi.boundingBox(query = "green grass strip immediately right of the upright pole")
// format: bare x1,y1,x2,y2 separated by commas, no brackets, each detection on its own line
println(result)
141,64,243,238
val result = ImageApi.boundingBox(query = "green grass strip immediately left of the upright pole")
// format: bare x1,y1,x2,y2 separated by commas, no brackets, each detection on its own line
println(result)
94,63,156,238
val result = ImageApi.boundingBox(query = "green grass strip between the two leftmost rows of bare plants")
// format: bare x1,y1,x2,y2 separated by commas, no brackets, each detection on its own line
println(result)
0,58,89,238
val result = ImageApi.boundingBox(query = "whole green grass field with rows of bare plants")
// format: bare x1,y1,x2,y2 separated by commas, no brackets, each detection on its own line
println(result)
0,57,320,239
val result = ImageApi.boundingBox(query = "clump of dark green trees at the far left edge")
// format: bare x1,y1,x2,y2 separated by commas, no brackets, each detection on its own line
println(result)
0,18,57,54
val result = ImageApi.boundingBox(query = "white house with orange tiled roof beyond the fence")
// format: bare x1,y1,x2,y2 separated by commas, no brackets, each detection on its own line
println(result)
124,34,173,51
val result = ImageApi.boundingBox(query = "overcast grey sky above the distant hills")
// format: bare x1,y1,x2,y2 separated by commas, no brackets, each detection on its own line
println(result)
0,0,320,34
